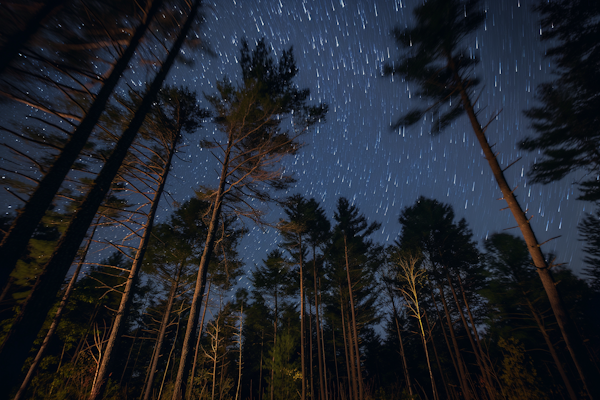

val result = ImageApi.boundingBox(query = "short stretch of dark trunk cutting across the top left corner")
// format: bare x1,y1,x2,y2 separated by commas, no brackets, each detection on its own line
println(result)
0,0,67,75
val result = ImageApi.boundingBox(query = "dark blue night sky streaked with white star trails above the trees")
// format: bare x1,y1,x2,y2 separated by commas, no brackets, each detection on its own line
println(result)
152,0,591,271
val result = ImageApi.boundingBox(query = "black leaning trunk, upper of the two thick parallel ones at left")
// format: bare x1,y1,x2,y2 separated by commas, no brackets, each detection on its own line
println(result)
0,0,164,290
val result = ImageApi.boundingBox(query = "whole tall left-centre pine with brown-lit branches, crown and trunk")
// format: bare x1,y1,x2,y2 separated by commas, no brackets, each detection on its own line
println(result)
173,40,326,400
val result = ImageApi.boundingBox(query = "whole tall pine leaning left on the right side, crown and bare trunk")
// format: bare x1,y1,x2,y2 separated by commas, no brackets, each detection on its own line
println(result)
385,0,600,397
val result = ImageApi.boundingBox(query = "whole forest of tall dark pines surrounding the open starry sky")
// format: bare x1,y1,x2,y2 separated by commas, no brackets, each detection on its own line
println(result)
0,0,600,400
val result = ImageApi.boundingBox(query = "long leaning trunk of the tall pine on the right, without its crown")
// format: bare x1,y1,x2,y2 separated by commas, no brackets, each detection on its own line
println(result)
447,56,600,399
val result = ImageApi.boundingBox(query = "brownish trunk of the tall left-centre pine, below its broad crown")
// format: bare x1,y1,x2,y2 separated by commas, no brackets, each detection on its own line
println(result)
172,125,233,400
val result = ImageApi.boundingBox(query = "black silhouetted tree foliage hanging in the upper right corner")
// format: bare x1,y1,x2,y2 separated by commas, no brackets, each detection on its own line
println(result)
520,0,600,201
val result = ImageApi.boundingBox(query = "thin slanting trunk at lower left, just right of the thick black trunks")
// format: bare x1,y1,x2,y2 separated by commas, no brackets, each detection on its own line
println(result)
13,224,98,400
